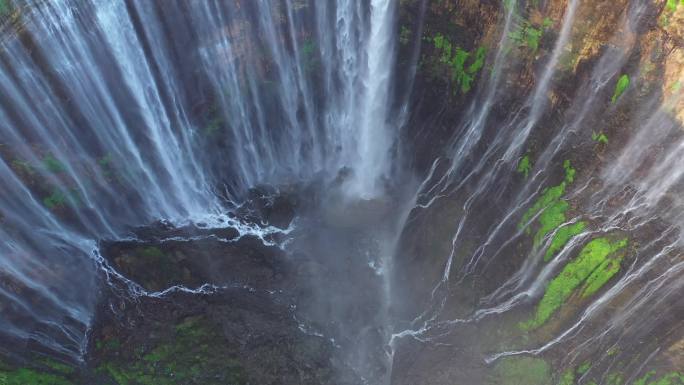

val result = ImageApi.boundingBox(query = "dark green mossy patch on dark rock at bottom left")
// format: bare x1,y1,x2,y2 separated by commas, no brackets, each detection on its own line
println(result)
98,317,247,385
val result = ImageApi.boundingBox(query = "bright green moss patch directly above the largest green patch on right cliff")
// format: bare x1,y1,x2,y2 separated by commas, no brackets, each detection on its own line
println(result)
518,160,577,250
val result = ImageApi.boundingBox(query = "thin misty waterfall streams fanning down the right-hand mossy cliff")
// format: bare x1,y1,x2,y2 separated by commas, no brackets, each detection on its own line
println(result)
391,0,683,384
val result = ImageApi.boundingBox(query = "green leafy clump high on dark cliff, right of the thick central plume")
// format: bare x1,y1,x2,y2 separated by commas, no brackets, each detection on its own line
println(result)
432,33,487,94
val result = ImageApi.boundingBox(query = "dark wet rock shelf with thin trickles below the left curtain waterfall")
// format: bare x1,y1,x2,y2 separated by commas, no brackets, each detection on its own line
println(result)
81,192,359,385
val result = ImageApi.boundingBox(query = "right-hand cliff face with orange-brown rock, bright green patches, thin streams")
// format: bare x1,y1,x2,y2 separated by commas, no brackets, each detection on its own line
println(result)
392,1,684,384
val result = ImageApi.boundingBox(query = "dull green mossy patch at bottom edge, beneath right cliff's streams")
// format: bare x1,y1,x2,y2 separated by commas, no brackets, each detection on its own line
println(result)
494,357,552,385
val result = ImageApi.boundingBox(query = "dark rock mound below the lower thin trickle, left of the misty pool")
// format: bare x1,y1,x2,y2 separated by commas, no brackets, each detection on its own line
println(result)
84,288,354,385
